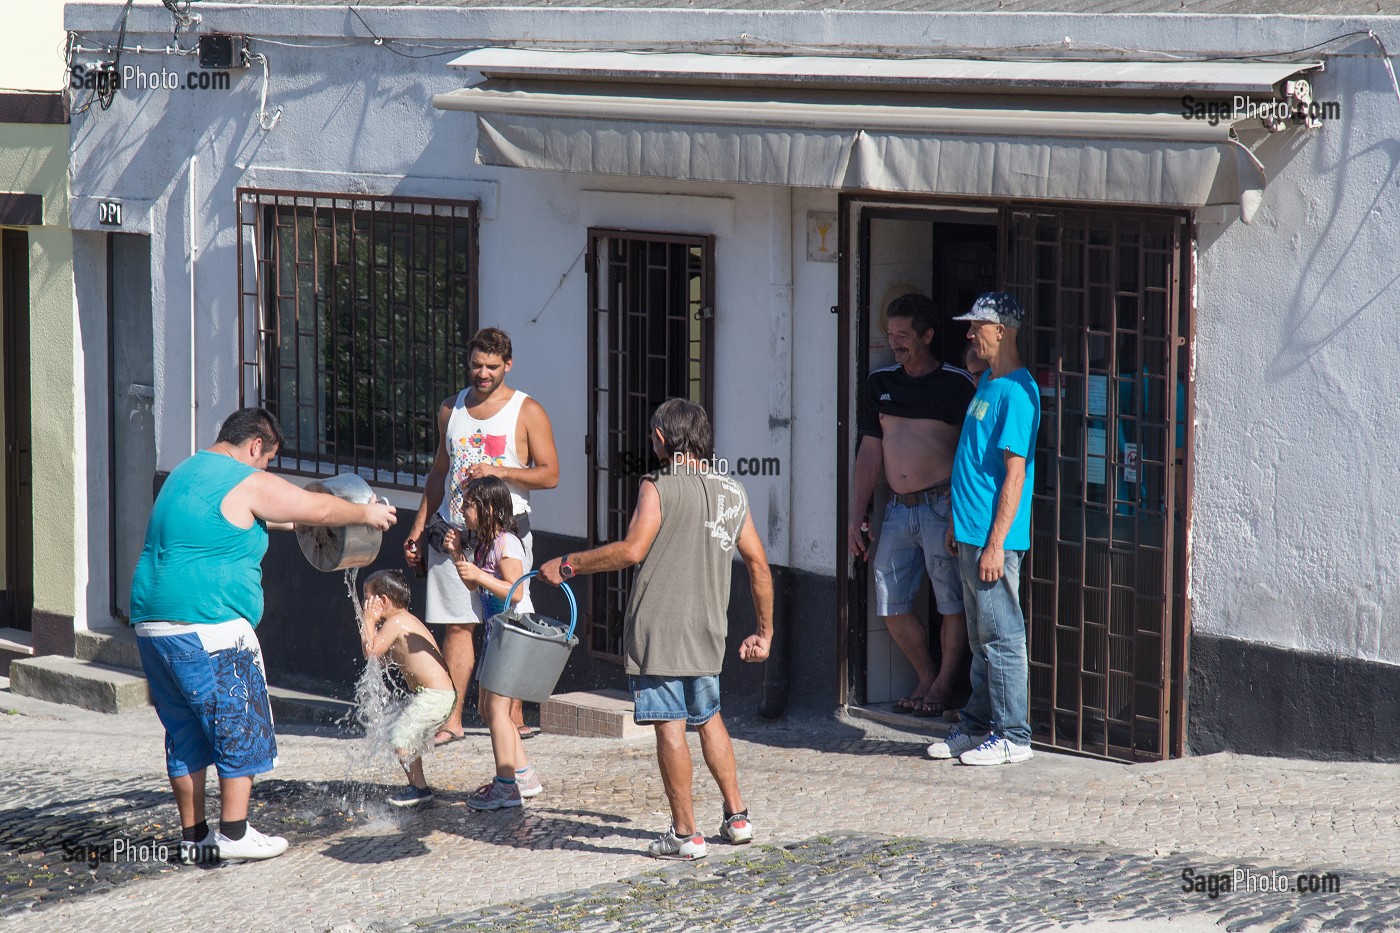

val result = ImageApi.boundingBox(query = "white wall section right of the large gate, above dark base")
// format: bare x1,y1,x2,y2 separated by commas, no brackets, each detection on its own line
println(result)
1191,46,1400,663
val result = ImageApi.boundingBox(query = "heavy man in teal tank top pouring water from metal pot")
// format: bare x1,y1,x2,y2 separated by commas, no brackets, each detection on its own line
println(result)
132,408,395,862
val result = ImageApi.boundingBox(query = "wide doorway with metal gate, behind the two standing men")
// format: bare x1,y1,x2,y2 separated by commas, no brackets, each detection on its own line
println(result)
837,196,1193,761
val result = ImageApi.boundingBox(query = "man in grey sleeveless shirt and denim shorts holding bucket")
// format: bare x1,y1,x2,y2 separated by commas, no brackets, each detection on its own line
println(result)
540,398,773,859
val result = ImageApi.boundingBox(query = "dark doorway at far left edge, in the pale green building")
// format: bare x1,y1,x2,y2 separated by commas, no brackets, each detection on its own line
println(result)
0,230,34,632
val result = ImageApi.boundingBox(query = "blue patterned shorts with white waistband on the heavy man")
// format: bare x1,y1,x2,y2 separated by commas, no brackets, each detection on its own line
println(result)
136,619,277,778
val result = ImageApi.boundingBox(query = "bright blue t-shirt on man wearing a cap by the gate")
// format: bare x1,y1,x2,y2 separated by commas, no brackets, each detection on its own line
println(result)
953,368,1040,551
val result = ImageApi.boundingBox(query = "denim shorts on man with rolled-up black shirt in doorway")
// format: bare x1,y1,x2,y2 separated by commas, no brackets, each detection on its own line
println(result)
875,493,963,615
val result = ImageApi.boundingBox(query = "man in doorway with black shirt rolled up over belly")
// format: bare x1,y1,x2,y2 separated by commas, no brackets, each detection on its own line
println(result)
847,294,976,716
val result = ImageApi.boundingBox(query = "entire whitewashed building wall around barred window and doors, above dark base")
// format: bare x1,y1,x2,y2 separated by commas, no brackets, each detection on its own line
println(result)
67,4,1400,663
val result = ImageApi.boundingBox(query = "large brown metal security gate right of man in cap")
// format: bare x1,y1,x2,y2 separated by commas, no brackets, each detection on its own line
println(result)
1001,209,1190,761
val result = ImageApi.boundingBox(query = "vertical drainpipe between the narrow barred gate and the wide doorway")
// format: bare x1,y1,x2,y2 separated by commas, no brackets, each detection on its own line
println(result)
759,186,795,719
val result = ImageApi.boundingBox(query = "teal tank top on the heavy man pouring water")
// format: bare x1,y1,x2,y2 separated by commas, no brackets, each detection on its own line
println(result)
132,450,267,625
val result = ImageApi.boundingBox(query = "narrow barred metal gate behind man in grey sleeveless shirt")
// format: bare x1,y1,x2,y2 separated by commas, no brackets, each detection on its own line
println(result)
587,228,714,660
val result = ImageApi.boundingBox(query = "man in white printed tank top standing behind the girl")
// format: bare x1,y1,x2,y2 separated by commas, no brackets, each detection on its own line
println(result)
403,328,559,745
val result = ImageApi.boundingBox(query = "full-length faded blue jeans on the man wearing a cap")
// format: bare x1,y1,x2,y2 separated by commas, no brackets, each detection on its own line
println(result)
958,544,1030,745
